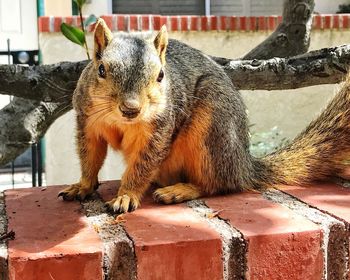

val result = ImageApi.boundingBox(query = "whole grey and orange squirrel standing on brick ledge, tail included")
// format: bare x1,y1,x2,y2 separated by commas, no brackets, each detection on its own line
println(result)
59,19,350,213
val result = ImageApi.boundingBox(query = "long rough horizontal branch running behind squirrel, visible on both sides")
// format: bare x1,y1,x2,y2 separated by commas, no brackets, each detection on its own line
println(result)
0,45,350,101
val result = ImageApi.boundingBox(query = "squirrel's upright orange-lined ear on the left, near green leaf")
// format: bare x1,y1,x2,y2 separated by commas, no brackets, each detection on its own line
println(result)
94,18,113,60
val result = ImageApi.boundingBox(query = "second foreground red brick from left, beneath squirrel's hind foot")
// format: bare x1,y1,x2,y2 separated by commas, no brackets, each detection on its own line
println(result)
99,182,223,280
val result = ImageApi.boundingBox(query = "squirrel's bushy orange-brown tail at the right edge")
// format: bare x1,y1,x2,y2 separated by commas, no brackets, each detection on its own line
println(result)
253,78,350,188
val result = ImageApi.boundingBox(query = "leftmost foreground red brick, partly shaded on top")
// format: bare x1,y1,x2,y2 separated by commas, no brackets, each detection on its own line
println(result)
5,187,102,280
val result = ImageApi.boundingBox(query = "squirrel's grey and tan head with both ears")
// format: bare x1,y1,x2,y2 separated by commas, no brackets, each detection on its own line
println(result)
90,19,168,123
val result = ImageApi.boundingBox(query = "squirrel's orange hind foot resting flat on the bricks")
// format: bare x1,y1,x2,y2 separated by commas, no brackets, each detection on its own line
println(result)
153,183,203,204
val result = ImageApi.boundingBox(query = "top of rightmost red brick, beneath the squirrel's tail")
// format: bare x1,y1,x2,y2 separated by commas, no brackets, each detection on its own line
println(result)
279,184,350,224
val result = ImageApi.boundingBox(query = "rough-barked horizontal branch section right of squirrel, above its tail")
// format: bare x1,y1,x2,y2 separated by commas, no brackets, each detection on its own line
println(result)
223,45,350,90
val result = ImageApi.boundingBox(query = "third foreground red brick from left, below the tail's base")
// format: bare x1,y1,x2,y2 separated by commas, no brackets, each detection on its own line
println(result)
205,193,323,280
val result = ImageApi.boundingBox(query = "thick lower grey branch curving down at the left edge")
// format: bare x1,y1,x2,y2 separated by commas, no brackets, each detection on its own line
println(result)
0,97,71,166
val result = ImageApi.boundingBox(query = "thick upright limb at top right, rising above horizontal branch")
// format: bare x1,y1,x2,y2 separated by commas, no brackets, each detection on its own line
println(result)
243,0,315,59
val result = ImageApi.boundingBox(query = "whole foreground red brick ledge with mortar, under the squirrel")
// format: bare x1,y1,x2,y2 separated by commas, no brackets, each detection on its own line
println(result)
0,182,350,280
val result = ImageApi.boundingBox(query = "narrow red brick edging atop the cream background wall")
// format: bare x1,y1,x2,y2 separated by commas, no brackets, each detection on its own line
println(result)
39,14,350,32
